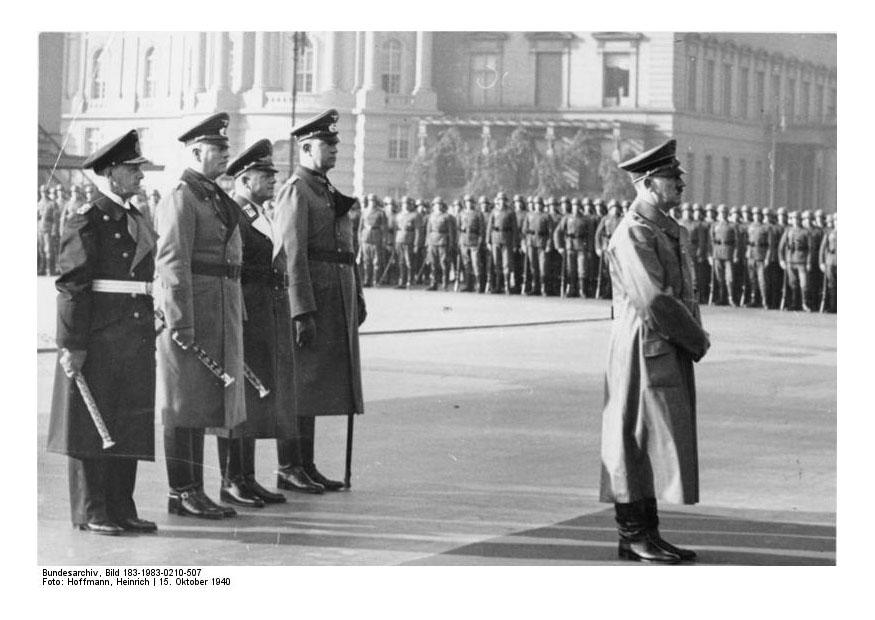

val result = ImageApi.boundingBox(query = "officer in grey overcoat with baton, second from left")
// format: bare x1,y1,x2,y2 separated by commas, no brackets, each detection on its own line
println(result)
155,112,246,519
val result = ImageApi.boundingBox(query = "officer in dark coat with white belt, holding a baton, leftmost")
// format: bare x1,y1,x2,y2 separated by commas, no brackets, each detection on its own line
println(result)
48,130,157,535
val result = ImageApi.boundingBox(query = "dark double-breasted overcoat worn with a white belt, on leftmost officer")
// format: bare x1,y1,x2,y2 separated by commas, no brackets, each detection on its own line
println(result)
48,195,155,461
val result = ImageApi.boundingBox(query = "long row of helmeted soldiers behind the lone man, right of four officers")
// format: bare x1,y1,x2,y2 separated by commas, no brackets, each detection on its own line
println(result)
340,192,838,312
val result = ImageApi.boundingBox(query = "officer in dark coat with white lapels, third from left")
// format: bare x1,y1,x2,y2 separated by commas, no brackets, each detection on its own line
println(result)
218,139,304,508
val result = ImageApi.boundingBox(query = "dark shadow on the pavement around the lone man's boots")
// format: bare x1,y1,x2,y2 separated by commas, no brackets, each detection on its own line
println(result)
407,509,836,566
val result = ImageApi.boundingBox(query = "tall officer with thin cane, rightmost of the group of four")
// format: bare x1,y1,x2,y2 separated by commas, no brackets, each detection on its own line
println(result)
275,110,367,491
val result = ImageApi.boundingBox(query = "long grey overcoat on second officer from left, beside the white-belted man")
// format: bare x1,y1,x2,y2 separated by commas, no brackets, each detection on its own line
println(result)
155,169,246,429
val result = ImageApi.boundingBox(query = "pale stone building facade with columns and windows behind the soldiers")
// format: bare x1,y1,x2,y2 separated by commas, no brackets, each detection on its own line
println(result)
41,31,837,211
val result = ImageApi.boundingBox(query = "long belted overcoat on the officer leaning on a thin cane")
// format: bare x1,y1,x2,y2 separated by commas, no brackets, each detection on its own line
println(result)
274,166,365,416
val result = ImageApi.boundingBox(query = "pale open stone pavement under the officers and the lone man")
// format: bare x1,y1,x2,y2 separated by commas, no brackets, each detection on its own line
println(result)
36,279,836,566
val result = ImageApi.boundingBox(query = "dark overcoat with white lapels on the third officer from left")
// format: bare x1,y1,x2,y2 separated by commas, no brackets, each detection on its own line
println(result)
234,196,296,438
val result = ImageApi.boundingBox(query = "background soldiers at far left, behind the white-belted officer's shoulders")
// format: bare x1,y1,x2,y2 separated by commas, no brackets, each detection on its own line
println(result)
36,183,161,276
